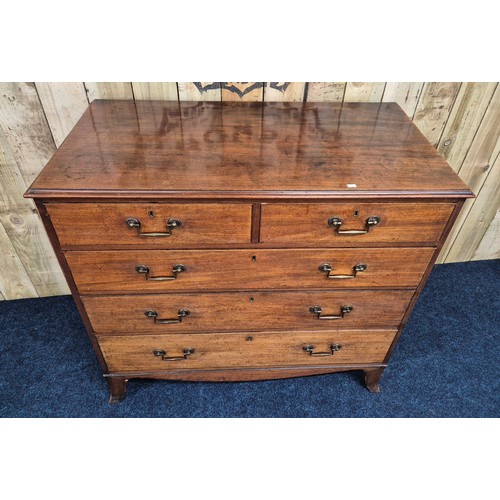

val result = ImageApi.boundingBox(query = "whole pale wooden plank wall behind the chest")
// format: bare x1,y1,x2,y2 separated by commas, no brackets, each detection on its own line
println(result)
0,82,500,300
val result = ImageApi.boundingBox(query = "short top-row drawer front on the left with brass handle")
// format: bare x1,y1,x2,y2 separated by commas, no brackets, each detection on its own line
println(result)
47,203,252,248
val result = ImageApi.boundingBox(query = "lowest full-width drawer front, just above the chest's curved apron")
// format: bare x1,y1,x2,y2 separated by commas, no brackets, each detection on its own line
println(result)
99,330,396,372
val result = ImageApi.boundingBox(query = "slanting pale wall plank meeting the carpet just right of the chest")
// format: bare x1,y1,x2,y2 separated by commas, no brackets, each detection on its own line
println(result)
445,156,500,262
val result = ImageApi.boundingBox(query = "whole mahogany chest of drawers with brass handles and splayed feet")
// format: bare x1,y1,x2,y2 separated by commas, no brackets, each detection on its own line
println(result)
26,101,472,401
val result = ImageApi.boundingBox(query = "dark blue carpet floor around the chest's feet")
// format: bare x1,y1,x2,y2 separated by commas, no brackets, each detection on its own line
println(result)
0,260,500,417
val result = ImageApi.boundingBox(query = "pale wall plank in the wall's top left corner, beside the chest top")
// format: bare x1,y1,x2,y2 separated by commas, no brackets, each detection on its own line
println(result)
0,82,56,184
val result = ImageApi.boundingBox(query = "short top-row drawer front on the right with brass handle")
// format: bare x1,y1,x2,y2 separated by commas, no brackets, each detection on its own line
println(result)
260,203,455,247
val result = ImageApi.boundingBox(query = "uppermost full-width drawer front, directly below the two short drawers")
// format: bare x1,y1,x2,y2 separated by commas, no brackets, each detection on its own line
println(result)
66,248,434,294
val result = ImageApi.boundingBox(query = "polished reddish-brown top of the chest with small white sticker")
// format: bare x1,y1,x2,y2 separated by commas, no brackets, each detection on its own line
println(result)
26,100,471,199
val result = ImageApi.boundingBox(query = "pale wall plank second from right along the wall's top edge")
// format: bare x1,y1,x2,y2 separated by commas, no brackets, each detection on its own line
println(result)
413,82,460,147
